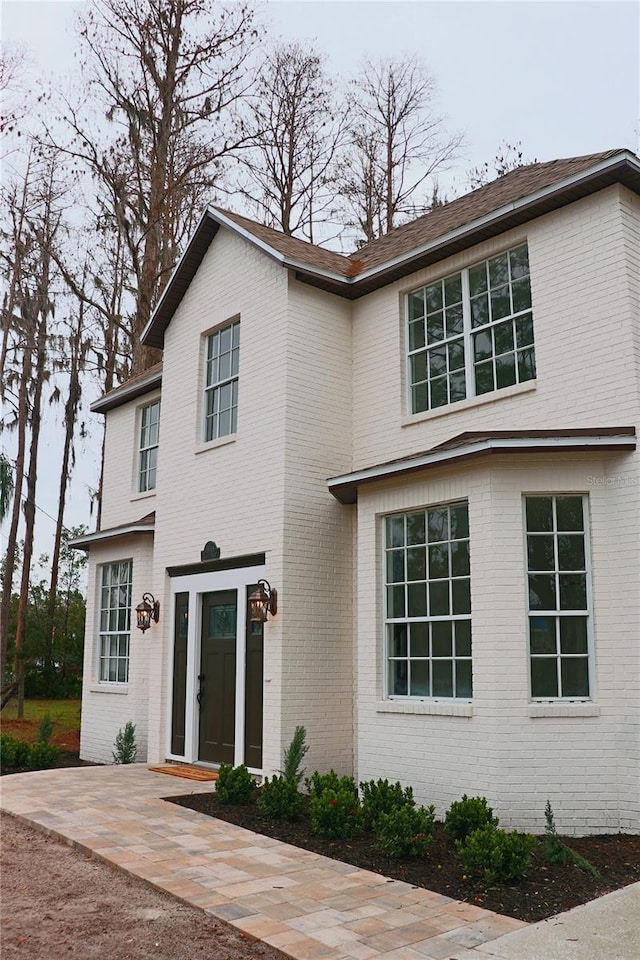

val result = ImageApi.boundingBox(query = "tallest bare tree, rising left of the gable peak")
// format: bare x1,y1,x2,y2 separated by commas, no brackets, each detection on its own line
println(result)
43,0,257,373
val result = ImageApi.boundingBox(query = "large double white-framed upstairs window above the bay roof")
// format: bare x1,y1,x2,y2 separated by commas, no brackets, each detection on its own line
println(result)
407,243,536,414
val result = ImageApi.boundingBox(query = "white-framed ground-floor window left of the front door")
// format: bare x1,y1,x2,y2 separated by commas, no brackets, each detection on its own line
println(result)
98,560,133,683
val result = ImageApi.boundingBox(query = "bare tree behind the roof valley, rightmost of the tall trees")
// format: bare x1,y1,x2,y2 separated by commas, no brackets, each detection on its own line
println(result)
341,56,462,242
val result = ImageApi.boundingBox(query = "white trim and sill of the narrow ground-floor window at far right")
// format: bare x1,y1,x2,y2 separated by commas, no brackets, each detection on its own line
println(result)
522,490,600,704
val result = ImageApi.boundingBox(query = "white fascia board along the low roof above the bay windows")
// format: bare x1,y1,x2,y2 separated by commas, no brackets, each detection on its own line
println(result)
327,434,636,490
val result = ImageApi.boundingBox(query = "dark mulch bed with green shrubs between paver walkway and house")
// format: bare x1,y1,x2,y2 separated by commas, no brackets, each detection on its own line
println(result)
170,793,640,922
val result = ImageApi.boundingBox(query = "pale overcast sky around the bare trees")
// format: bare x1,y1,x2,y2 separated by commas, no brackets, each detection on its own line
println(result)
0,0,640,568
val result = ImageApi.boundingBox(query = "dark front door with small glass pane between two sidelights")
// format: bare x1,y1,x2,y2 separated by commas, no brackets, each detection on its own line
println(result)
198,590,237,763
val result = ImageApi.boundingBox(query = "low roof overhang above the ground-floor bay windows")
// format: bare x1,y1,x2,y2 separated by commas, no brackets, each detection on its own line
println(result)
327,427,636,504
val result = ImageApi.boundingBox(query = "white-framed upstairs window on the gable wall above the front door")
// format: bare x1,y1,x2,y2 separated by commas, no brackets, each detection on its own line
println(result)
204,320,240,441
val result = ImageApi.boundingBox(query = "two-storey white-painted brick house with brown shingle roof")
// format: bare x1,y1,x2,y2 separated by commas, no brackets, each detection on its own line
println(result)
76,150,640,833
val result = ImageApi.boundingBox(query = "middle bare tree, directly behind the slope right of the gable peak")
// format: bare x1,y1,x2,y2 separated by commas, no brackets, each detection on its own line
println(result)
232,43,343,242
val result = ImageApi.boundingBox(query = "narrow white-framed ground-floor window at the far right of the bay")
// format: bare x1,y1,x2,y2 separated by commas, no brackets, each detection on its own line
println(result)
524,494,592,700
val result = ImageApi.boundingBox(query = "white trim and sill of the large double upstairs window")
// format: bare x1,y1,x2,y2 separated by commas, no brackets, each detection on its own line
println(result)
402,237,538,414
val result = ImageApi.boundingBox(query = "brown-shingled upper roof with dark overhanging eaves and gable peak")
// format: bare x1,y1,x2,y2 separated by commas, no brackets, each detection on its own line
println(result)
141,150,640,348
